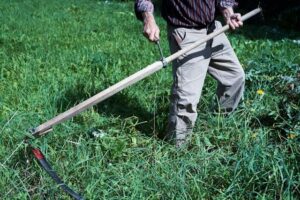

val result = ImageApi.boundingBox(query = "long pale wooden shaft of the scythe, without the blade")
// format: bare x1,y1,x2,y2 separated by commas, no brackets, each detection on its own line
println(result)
31,8,261,136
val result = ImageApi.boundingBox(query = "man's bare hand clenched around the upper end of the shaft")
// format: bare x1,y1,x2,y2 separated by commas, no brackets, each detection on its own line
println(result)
221,8,243,30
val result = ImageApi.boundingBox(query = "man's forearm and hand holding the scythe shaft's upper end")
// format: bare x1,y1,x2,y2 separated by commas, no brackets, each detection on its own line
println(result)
219,0,243,30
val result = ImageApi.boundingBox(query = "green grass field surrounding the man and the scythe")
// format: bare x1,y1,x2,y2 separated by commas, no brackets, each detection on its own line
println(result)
0,0,300,199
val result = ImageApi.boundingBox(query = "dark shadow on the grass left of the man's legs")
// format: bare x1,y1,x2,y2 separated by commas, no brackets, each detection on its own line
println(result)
56,83,168,139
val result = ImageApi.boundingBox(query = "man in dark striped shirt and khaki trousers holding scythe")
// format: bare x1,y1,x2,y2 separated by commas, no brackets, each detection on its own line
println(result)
135,0,245,147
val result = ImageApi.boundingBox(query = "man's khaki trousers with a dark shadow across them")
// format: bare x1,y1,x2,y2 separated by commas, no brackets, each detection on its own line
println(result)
168,21,245,146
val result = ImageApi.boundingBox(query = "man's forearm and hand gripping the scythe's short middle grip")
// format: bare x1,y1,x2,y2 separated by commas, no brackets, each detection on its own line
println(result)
135,0,159,42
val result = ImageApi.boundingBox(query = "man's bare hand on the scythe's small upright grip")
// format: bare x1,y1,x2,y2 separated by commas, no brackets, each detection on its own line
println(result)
143,12,159,42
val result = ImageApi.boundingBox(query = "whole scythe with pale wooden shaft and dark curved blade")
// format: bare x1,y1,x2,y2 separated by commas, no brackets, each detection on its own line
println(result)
30,8,262,199
